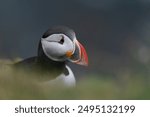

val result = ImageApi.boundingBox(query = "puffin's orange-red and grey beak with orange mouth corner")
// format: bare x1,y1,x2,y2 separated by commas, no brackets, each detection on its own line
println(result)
66,39,88,66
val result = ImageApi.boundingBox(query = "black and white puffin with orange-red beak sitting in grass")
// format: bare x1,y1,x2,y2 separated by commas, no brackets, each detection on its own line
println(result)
14,26,88,86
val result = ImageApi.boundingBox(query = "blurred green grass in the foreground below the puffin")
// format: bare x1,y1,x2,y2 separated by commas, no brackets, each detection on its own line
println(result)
0,60,150,99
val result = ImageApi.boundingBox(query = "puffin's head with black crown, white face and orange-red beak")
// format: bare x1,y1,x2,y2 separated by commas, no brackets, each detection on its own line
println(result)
39,26,88,66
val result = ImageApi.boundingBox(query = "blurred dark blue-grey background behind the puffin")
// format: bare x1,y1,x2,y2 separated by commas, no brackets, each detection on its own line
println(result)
0,0,150,82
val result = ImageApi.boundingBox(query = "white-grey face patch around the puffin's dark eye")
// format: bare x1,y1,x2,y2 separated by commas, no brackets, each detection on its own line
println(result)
41,34,75,61
